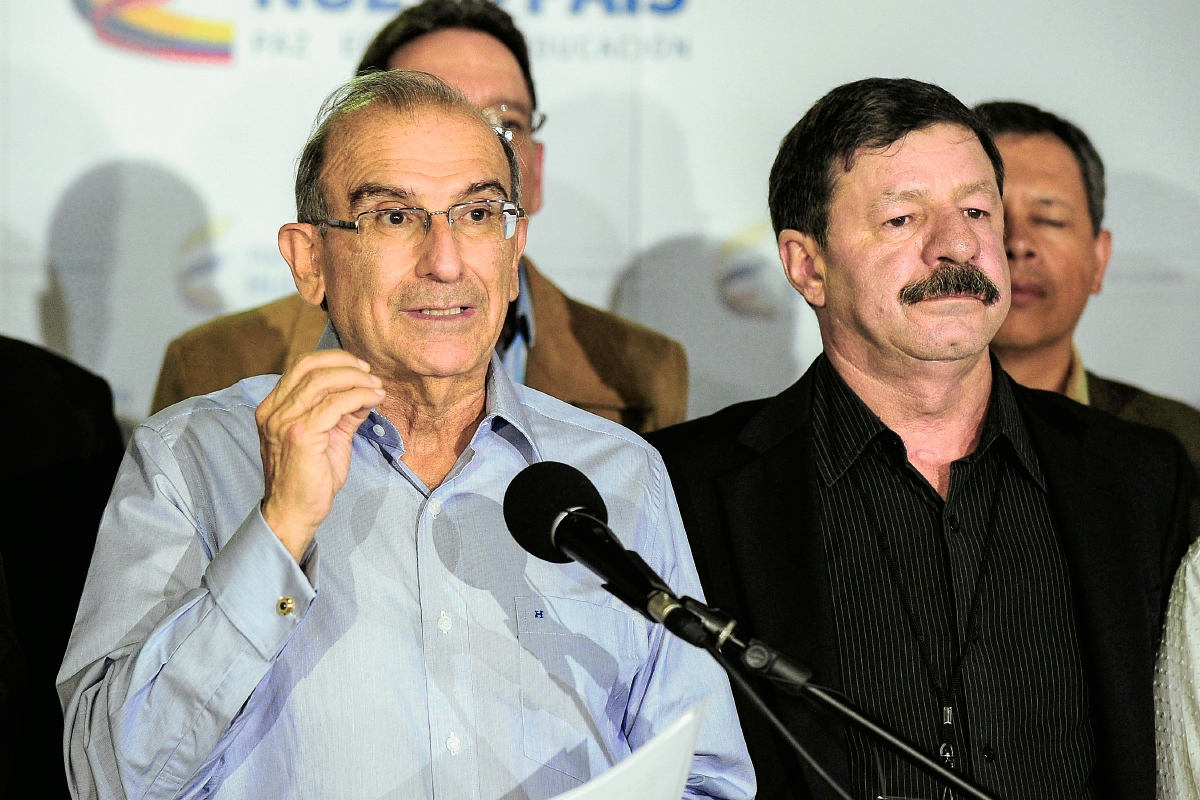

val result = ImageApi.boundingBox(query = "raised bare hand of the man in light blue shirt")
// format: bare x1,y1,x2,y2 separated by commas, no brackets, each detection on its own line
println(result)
254,350,384,561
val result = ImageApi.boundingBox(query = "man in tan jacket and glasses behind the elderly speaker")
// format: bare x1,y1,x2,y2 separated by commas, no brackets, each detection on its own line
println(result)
151,0,688,433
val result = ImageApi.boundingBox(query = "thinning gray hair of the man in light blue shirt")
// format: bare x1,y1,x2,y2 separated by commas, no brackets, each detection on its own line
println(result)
296,70,521,225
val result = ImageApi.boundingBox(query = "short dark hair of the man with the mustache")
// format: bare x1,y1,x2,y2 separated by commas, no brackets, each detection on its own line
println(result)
767,78,1004,247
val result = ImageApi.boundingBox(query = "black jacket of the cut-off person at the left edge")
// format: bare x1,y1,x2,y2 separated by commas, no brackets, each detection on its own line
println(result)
0,336,125,800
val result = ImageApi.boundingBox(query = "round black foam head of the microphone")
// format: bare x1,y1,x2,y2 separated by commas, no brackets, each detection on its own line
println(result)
504,461,608,564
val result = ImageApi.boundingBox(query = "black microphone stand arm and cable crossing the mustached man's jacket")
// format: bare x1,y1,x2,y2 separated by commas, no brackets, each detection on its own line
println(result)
648,591,997,800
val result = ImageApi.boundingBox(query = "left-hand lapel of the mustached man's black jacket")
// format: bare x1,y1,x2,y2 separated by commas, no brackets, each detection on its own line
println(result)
718,371,848,799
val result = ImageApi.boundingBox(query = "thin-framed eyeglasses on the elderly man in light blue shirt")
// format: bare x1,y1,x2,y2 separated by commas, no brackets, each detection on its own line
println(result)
324,200,526,247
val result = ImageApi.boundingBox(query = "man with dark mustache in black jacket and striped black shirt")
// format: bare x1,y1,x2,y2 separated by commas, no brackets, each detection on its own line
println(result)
649,79,1195,800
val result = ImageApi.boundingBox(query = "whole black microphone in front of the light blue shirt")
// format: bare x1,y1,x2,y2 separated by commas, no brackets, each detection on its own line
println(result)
504,461,709,648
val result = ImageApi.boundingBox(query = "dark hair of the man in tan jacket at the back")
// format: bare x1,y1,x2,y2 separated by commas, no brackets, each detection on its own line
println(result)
358,0,538,108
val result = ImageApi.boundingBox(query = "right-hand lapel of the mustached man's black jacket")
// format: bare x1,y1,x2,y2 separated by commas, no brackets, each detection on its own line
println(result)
1019,391,1154,800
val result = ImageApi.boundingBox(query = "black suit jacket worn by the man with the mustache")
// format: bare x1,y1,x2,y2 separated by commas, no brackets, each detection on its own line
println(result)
648,369,1195,800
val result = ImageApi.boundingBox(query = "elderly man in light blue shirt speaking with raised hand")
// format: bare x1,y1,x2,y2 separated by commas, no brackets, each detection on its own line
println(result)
59,71,755,800
